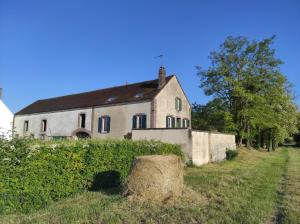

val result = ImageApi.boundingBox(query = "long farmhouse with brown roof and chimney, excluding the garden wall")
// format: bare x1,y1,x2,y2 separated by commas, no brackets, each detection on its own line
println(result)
14,67,191,139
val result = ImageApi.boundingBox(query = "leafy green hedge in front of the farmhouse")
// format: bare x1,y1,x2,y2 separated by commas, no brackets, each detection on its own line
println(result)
0,139,183,214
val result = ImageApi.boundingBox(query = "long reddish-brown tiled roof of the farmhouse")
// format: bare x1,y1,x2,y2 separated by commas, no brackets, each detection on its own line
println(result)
16,76,173,115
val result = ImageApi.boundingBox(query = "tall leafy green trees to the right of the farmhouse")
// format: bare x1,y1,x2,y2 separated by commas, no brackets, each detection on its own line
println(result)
192,36,300,150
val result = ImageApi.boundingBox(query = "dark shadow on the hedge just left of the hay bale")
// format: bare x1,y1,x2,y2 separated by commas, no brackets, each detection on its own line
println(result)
89,170,122,195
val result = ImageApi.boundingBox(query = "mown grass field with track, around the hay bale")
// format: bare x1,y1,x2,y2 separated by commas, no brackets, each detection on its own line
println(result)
0,149,300,224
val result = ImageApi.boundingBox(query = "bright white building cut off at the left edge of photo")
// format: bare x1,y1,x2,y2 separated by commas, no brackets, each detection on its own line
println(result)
0,99,14,138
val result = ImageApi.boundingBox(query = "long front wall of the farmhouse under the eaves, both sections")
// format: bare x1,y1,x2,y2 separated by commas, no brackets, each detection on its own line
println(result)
14,102,151,139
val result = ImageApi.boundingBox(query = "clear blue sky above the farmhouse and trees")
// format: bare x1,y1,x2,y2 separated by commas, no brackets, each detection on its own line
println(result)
0,0,300,112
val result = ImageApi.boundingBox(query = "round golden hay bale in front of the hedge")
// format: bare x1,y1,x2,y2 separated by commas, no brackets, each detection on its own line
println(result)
125,155,183,201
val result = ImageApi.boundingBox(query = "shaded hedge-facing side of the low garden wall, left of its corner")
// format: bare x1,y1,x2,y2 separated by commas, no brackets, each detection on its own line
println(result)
132,129,192,160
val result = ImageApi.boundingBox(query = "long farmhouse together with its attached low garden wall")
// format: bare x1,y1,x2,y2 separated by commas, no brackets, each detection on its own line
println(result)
14,67,235,165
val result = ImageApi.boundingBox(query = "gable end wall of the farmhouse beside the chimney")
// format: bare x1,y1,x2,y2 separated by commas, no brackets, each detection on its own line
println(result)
154,76,191,128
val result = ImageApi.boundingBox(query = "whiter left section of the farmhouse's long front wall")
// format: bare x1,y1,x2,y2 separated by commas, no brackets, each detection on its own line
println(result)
14,108,92,138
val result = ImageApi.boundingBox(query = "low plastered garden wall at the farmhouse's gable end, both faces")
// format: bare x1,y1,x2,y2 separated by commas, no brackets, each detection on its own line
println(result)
132,128,236,165
